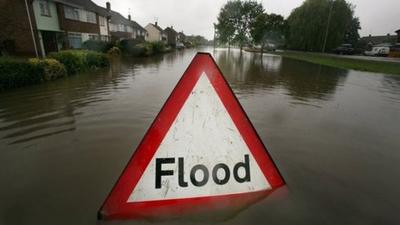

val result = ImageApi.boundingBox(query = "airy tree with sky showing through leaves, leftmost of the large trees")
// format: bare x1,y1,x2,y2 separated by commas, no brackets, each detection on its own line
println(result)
216,0,264,50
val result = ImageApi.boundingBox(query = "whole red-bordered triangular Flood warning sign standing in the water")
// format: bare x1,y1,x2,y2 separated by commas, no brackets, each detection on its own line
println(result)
99,53,284,219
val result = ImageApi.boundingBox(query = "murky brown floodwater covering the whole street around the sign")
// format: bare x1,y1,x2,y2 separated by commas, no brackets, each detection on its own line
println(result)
0,49,400,225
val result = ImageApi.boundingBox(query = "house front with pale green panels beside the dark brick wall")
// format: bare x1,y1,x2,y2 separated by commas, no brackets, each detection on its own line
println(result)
32,0,110,56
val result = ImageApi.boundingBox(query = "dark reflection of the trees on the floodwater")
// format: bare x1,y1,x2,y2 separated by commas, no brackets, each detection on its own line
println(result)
215,50,348,101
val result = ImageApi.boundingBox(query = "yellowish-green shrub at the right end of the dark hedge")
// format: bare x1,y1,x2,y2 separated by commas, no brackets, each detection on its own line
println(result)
29,58,67,81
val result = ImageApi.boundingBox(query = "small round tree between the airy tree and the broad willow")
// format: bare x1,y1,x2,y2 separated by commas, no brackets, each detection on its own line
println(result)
251,13,286,54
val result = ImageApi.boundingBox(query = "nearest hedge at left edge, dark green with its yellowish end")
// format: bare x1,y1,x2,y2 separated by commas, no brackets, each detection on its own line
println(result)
0,58,67,90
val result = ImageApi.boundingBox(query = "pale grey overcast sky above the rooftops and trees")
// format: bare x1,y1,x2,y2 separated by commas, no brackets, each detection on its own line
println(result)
93,0,400,39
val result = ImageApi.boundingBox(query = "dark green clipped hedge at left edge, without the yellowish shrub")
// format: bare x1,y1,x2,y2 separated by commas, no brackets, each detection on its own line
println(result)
0,58,45,90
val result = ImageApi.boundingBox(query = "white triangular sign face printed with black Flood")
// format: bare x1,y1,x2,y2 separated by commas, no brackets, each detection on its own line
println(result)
127,73,272,203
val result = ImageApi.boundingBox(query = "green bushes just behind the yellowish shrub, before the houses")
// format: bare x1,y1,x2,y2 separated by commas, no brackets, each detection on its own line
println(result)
49,50,110,74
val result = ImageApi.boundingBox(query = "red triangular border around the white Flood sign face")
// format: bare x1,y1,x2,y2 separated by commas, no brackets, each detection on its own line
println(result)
98,53,284,220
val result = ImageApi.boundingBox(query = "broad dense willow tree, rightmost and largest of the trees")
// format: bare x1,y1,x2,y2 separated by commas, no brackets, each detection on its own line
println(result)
287,0,358,51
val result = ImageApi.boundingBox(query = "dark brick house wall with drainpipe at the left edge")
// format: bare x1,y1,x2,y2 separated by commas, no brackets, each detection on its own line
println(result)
0,0,41,56
